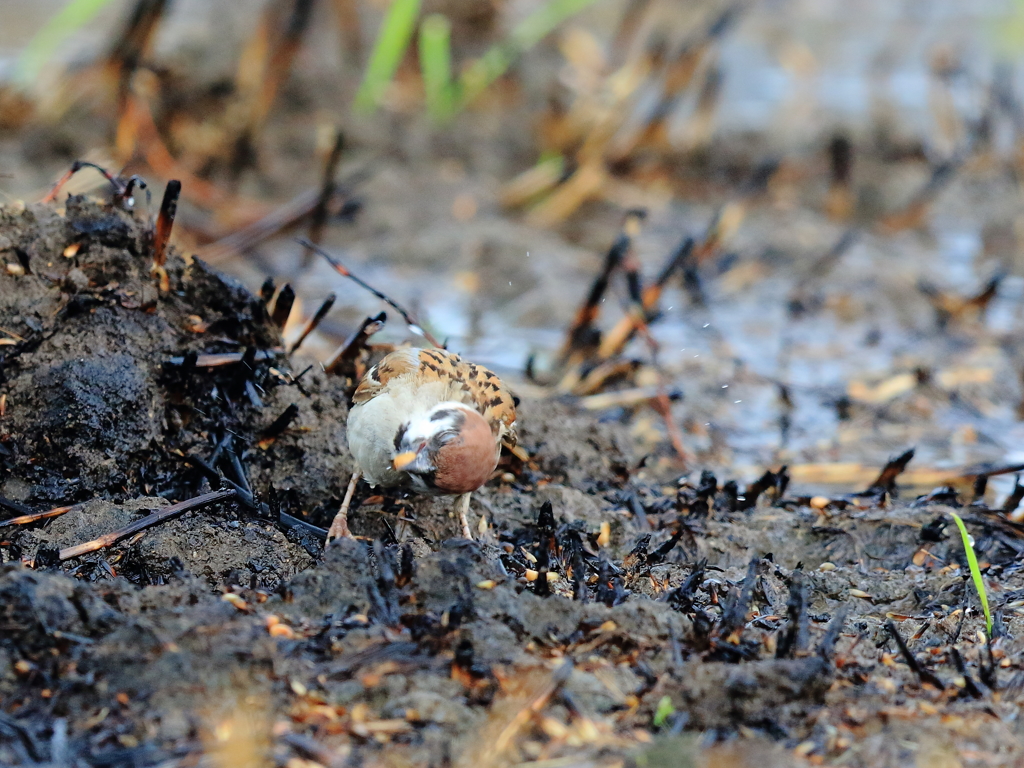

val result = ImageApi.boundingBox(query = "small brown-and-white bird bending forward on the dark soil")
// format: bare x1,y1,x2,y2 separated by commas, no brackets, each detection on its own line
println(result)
328,347,517,541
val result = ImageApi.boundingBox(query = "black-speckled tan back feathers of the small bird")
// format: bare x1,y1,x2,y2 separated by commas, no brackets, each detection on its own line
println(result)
352,347,516,447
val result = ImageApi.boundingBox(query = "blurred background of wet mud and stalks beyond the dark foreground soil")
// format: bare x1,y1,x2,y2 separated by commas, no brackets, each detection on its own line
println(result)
0,0,1024,495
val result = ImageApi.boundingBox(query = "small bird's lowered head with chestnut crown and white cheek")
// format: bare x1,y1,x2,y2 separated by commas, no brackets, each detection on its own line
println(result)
391,402,499,495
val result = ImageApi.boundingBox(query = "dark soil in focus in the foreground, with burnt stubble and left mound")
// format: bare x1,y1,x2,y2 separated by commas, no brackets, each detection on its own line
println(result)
0,198,1024,766
